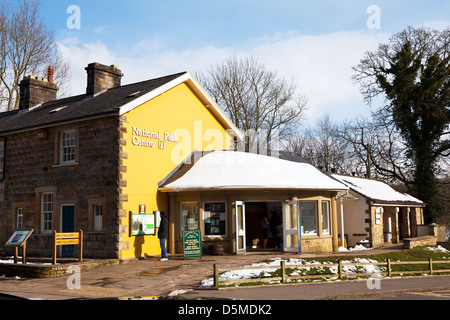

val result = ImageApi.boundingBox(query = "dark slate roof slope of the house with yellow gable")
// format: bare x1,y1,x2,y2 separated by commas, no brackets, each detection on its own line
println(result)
0,72,186,134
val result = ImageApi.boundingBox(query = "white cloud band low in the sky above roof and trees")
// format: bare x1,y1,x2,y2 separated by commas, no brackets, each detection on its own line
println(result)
59,30,390,121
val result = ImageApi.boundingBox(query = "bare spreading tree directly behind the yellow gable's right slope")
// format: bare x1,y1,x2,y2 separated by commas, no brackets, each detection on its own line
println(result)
199,56,307,148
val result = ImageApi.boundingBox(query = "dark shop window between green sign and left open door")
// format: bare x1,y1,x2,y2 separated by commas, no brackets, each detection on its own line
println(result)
203,202,226,236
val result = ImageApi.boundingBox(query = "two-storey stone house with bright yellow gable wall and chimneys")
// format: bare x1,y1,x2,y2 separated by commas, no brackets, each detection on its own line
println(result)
0,63,237,259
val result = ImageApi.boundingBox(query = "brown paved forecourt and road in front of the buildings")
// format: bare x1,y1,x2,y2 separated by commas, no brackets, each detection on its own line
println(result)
0,246,450,300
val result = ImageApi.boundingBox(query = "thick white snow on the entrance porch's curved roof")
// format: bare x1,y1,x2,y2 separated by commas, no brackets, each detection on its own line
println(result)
162,151,348,191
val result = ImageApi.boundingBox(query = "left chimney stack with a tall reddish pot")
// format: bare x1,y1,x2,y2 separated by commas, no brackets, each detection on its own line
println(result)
19,67,58,110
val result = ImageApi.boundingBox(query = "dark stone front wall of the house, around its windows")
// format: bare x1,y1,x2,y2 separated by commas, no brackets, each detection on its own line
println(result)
0,117,120,258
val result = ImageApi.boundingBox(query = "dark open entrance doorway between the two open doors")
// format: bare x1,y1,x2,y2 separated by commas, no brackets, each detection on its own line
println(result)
245,201,283,251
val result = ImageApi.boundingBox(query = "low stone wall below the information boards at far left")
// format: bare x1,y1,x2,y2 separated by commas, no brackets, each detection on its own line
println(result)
0,259,120,278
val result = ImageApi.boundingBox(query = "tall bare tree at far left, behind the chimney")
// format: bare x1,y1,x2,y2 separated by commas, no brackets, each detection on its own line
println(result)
0,0,70,111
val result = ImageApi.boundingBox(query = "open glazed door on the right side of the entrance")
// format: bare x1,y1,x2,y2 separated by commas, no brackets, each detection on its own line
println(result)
282,201,302,253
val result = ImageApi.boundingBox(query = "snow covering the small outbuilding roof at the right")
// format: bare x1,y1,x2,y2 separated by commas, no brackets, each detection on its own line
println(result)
331,174,424,205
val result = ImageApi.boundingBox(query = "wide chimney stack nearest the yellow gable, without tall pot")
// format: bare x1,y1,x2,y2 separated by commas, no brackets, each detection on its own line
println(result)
85,62,123,96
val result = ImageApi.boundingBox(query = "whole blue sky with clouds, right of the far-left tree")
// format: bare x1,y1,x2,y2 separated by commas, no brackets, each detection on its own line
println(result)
38,0,450,121
